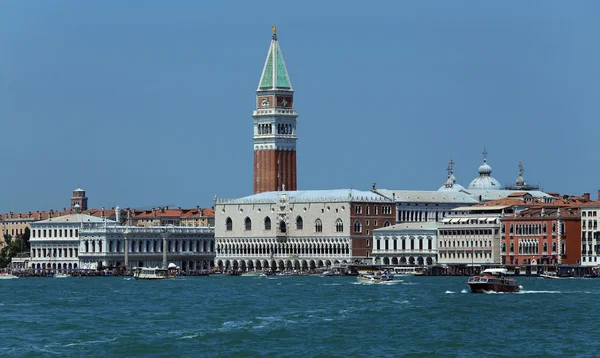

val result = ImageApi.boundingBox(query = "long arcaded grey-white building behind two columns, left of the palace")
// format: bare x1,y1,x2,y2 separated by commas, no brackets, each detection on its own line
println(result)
78,222,215,271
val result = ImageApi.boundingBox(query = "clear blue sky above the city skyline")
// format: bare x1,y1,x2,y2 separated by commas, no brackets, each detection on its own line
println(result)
0,1,600,212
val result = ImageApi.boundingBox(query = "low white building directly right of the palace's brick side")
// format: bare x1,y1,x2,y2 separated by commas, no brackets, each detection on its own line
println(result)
373,221,437,266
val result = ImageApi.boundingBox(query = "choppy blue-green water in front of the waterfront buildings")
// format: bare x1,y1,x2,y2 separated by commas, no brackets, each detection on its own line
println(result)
0,276,600,357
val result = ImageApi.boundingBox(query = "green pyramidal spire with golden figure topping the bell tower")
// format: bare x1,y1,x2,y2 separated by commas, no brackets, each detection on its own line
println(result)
257,26,293,91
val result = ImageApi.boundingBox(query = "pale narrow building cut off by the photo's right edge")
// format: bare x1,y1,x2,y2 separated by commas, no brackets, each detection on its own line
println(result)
579,199,600,267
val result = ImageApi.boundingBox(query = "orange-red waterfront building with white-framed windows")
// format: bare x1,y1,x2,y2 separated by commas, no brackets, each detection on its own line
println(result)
501,202,582,270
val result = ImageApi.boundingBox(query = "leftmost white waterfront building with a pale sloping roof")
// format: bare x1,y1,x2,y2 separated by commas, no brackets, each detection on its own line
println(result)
29,213,116,270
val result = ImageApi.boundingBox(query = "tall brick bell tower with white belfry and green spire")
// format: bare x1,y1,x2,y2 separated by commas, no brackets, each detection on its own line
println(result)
252,26,298,194
